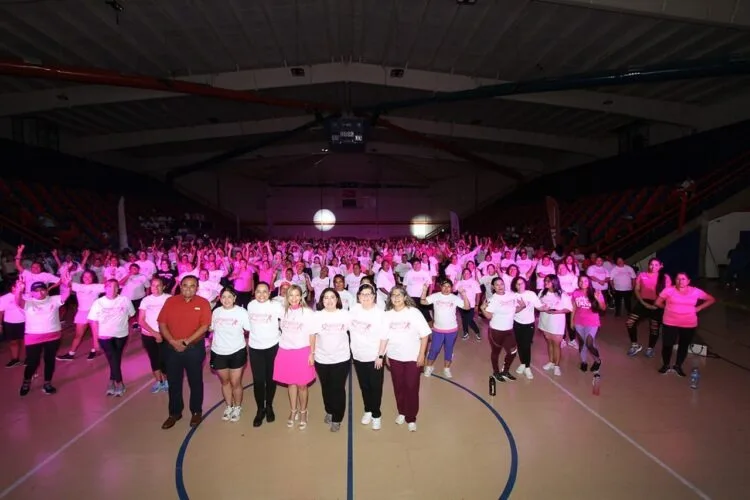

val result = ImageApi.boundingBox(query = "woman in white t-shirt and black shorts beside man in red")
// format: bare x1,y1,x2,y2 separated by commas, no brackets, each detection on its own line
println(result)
211,287,250,422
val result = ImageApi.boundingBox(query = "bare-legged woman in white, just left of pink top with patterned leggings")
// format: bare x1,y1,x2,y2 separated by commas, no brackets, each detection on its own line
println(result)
539,274,573,377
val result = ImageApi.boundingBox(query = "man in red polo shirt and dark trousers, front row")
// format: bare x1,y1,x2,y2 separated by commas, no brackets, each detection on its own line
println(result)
158,276,211,429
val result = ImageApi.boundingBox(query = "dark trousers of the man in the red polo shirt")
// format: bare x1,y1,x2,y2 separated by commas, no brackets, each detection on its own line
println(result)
162,340,206,417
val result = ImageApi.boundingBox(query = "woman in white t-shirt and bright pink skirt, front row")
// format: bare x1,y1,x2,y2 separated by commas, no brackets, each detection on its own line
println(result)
273,285,316,430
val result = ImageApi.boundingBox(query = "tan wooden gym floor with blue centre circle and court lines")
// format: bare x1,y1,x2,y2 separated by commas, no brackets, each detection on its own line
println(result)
0,284,750,500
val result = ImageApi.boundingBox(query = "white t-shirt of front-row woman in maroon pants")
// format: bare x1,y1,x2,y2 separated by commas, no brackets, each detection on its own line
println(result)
383,306,432,361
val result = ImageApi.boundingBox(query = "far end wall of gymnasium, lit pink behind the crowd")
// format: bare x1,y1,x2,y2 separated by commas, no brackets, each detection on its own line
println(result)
178,154,509,238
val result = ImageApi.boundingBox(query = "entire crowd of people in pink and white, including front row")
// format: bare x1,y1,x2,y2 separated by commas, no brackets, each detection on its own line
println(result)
0,236,714,432
